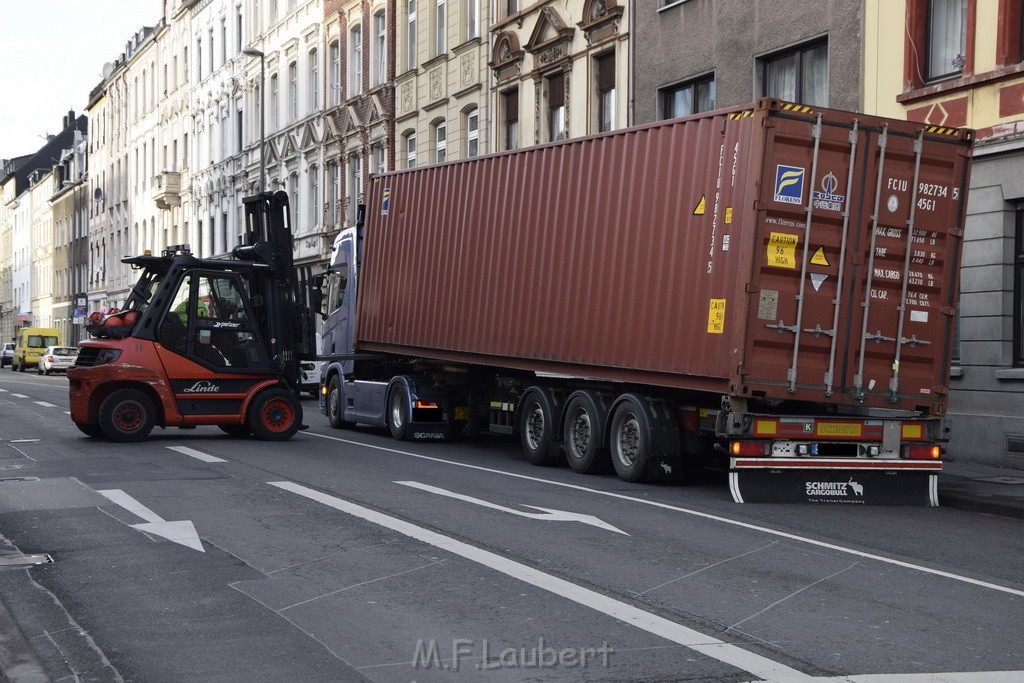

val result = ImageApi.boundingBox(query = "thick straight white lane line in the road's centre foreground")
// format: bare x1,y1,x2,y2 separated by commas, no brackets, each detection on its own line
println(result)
267,481,811,681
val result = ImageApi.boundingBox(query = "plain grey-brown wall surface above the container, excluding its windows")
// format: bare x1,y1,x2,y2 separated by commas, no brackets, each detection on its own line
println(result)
633,0,863,123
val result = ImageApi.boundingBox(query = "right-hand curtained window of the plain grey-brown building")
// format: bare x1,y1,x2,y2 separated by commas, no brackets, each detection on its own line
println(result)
760,42,828,106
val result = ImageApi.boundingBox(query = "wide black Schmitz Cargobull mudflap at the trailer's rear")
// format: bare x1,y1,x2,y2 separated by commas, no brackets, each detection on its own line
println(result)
729,458,942,507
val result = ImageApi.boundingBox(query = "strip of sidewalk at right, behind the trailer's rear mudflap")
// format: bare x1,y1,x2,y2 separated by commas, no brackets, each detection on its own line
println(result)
939,461,1024,519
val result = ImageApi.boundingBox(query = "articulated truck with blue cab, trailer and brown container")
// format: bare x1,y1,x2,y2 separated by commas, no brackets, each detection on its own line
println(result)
321,98,972,505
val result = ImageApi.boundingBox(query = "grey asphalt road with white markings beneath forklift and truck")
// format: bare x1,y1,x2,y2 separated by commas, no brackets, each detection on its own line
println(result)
0,370,1024,681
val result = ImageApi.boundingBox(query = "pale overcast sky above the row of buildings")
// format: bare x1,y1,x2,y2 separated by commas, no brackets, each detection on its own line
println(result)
0,0,163,159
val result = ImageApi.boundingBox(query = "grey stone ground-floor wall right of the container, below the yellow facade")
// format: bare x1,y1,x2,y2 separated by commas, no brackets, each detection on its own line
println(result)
948,142,1024,469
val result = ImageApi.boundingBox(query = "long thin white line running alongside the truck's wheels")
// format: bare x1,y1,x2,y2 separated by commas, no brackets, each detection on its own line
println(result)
306,432,1024,597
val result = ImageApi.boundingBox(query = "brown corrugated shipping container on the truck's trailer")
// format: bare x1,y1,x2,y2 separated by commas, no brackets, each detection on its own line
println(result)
356,99,971,415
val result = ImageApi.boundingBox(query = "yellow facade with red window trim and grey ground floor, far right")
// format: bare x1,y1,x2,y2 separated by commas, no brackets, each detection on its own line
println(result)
865,0,1024,469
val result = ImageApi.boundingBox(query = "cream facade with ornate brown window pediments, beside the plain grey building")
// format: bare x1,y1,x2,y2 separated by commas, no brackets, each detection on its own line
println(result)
487,0,626,150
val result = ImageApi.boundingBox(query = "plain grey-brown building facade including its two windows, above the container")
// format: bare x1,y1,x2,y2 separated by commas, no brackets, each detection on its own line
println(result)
633,0,864,123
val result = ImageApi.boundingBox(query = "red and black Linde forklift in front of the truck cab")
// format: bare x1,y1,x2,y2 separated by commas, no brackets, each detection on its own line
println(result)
68,191,323,441
